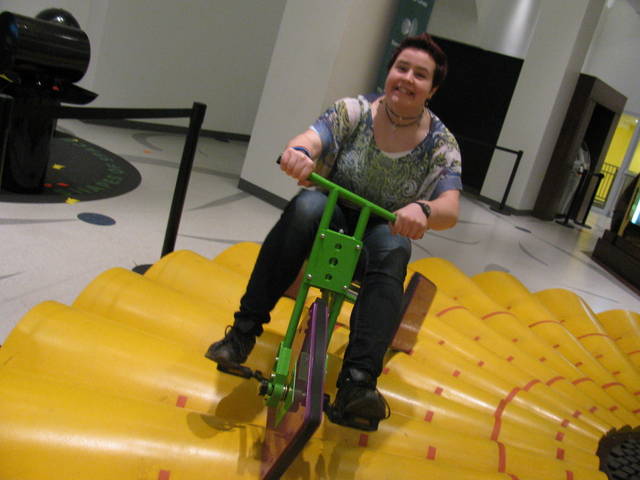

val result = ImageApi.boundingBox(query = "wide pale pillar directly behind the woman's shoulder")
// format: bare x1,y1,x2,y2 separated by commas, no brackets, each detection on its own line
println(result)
240,0,395,205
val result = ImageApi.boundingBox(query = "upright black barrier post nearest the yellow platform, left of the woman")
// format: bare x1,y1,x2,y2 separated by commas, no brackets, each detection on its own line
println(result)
161,102,207,257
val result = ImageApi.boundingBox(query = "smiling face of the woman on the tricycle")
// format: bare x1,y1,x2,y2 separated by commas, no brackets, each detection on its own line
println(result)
384,47,437,110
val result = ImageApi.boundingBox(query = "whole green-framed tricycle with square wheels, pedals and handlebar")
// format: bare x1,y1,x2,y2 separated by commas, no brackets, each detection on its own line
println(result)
218,173,435,479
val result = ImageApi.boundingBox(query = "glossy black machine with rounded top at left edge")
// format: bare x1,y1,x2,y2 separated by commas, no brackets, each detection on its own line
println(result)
0,8,97,193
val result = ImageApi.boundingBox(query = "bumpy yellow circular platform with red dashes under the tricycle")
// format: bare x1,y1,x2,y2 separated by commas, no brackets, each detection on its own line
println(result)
0,243,640,480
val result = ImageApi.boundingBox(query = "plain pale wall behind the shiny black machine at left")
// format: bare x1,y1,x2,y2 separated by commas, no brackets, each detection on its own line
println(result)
0,0,286,134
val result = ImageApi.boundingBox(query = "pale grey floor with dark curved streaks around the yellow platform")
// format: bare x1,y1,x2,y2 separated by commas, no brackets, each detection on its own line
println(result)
0,121,640,343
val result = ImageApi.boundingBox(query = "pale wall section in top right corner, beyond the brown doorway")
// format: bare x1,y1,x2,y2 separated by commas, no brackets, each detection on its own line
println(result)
583,0,640,115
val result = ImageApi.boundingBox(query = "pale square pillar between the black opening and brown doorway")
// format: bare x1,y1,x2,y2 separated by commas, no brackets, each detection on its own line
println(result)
480,0,605,211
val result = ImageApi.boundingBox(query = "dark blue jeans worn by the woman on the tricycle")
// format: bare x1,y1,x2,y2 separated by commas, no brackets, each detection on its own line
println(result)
234,190,411,378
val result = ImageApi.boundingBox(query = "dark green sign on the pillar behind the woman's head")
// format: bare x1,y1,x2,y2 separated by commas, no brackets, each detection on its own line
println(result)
376,0,436,93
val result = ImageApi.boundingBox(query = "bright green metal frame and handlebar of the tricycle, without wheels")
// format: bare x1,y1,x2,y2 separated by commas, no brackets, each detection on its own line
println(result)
265,173,396,422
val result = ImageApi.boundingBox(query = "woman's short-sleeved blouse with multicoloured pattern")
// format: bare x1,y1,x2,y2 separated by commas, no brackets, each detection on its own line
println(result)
311,95,462,212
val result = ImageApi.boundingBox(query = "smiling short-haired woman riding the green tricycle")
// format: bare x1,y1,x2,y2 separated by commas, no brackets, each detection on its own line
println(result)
206,34,462,430
